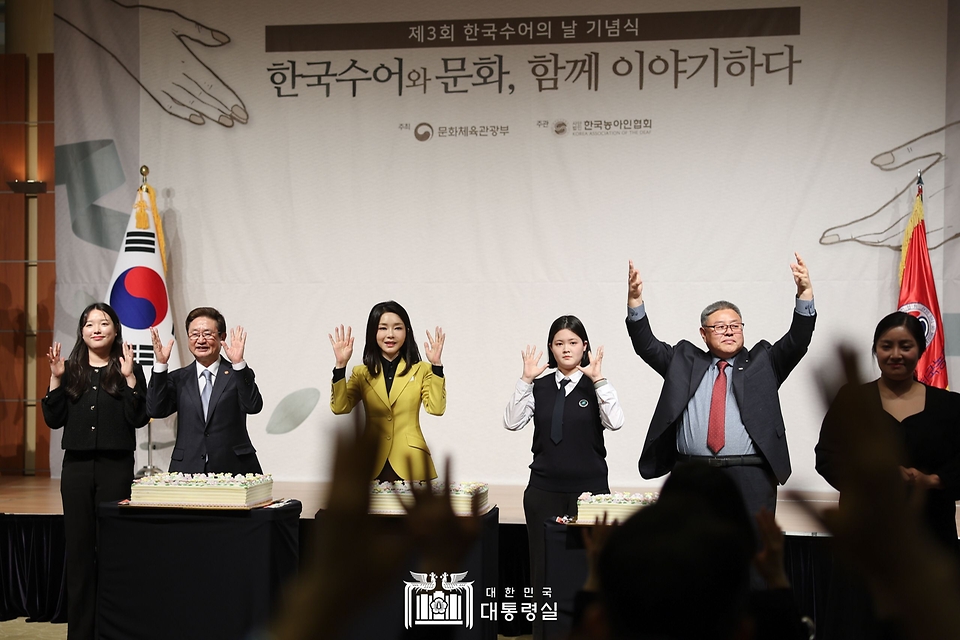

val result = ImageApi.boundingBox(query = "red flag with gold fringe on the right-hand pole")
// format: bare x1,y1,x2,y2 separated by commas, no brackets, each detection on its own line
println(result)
897,172,947,389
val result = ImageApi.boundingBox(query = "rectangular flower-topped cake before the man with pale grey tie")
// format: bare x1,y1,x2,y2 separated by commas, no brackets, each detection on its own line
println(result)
130,473,273,509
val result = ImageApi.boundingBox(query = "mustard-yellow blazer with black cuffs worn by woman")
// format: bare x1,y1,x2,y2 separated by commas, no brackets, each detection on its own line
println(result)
330,361,447,480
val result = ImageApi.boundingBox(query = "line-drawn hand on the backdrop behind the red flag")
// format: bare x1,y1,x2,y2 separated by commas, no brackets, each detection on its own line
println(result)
820,120,960,251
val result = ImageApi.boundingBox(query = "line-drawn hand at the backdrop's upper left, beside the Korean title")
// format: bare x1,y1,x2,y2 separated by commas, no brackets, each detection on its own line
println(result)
54,0,249,127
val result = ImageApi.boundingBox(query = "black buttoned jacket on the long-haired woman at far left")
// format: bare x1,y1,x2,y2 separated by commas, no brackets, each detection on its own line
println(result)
40,363,149,451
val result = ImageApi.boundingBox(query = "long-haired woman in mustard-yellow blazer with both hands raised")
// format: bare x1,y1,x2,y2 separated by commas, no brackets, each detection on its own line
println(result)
328,300,447,482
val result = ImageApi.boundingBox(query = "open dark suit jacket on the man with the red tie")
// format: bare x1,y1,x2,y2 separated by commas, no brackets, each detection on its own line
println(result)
627,312,816,484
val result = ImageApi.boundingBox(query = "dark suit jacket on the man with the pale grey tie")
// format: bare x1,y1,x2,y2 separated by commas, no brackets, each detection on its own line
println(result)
147,357,263,473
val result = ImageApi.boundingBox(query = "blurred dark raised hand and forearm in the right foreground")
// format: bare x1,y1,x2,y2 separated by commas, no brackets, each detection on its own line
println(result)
793,349,960,640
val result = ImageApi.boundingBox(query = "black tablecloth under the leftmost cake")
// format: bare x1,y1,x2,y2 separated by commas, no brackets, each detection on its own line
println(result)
98,500,301,640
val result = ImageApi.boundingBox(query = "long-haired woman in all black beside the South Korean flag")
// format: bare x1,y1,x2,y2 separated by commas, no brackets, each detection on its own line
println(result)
41,303,147,640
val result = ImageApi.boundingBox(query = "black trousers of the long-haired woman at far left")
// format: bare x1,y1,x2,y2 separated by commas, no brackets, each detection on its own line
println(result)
60,451,134,640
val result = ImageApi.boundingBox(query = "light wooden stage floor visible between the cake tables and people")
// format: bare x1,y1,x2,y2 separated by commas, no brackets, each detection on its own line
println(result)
0,476,838,535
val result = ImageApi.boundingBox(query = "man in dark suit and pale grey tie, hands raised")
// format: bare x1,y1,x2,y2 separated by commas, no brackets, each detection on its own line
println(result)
147,307,263,473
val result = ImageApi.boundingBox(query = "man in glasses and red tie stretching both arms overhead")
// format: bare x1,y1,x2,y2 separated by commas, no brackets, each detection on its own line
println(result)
627,254,816,515
